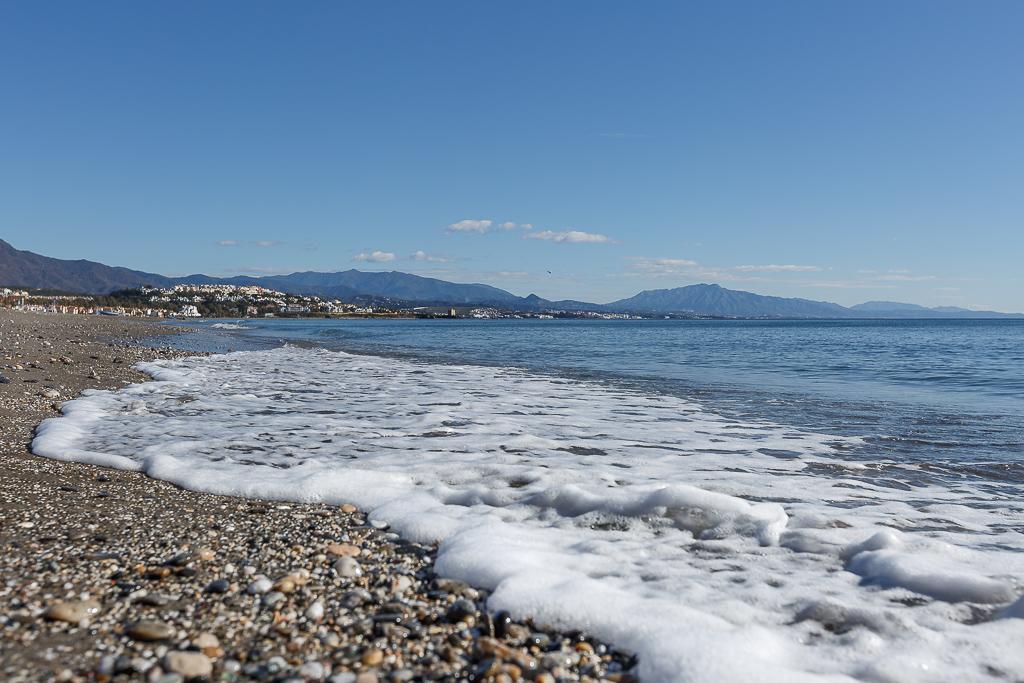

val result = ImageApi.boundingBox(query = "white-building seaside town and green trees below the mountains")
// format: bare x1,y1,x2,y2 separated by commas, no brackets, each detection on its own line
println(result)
0,285,643,319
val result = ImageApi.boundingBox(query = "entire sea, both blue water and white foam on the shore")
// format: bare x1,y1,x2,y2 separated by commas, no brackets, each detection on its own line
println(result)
34,319,1024,681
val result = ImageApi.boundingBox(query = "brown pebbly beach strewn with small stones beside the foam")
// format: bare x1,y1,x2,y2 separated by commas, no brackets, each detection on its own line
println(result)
0,310,633,683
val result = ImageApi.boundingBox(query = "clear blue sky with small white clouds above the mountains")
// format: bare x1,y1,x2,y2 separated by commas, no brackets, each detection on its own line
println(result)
0,0,1024,310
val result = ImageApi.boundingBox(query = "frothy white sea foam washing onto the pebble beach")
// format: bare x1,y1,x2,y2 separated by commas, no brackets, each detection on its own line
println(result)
33,348,1024,681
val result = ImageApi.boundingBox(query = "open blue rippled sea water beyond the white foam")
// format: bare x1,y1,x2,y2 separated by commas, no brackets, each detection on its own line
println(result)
172,318,1024,487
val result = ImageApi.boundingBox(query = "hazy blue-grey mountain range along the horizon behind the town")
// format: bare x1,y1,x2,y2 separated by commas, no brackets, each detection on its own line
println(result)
0,240,1024,318
